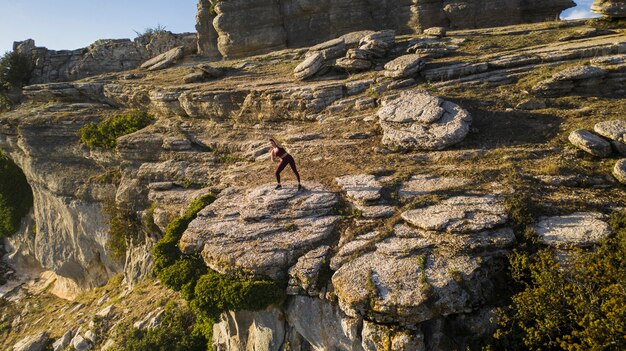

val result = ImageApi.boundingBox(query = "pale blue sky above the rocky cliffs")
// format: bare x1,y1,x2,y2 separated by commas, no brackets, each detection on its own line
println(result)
0,0,593,54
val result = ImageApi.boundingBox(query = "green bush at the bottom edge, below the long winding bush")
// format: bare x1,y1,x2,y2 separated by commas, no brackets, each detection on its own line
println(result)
116,303,207,351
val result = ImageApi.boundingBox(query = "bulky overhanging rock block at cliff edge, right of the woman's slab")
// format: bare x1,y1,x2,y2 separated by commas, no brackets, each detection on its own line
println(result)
332,225,515,325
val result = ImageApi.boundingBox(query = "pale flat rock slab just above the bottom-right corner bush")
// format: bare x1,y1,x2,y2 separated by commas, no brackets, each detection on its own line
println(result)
535,212,611,248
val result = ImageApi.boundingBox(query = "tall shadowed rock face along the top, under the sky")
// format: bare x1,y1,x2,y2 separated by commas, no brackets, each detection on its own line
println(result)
196,0,575,58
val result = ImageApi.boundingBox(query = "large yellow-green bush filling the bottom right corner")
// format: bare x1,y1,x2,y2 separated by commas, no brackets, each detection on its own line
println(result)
495,213,626,351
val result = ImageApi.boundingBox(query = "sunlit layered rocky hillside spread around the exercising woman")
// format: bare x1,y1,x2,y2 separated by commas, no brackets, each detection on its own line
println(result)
0,18,626,350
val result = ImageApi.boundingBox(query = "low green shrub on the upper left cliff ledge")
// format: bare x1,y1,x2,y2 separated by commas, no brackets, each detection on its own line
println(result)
79,110,154,150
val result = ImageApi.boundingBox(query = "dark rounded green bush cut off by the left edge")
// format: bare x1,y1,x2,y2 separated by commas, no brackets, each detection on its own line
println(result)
0,150,33,238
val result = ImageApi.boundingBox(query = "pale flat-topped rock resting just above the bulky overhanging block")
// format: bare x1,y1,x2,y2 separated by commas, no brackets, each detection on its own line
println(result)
402,195,508,233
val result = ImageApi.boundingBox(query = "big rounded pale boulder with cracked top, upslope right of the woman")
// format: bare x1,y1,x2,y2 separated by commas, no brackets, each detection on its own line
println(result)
378,91,472,150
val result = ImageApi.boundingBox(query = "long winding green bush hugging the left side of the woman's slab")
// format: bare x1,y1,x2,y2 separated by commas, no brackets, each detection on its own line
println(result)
152,195,284,348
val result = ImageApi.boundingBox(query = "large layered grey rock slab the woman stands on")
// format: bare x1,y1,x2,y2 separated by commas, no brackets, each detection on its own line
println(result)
180,184,338,279
